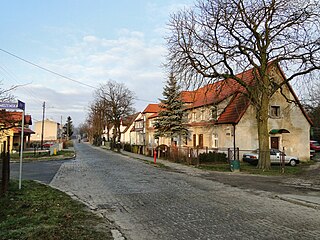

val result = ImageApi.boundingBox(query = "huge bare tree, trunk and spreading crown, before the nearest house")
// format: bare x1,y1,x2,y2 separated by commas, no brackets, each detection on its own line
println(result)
167,0,320,169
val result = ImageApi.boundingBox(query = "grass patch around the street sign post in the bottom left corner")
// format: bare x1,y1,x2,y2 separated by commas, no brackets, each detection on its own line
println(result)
0,180,113,240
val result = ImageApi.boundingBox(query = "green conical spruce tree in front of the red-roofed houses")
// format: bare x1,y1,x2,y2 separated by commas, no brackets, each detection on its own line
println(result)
154,74,188,144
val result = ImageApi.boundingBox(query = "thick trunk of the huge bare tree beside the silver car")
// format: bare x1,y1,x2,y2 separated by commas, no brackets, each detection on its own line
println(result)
257,93,271,170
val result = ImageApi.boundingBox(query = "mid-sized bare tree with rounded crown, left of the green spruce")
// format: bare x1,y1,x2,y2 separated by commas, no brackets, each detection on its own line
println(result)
96,81,134,150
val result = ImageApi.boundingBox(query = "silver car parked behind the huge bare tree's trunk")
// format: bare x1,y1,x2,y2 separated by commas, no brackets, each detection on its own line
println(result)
242,148,300,167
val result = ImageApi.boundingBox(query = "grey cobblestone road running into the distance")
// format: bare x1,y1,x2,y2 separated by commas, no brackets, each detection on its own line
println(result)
51,143,320,240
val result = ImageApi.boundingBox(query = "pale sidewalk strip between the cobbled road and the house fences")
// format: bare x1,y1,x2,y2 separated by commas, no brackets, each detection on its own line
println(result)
115,150,320,209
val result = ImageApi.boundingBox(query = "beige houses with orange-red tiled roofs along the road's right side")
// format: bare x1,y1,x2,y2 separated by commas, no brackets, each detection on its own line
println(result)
104,63,312,161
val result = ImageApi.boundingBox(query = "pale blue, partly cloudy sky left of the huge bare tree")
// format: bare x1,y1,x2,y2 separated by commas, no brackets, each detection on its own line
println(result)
0,0,194,126
